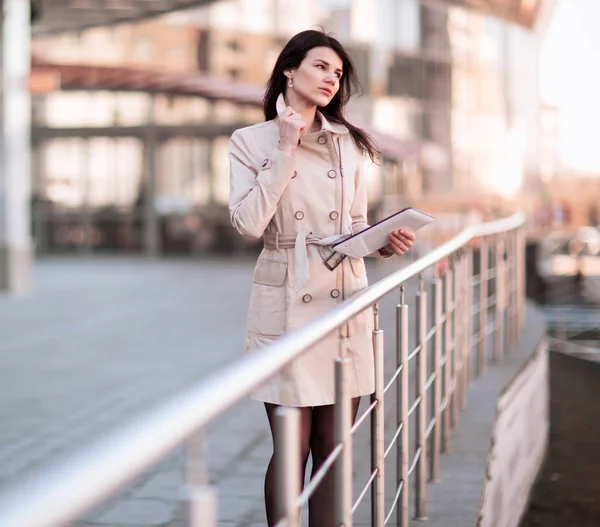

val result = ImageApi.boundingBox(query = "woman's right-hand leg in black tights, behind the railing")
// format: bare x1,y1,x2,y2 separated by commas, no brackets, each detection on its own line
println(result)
308,397,360,527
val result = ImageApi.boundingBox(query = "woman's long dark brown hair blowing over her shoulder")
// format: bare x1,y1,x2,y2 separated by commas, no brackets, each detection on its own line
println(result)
263,29,379,161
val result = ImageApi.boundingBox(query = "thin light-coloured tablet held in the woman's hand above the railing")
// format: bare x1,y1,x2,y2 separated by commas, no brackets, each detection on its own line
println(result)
332,207,435,258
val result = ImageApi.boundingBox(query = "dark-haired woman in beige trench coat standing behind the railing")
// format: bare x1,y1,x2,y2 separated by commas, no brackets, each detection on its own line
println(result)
229,30,415,527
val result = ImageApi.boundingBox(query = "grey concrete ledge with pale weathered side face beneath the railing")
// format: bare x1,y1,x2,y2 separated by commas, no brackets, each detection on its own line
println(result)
410,304,549,527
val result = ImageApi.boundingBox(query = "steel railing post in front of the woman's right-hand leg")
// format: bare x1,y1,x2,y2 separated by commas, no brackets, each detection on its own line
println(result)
334,357,352,527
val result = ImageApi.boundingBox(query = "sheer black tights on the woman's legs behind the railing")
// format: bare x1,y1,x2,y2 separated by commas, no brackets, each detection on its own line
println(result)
265,397,360,527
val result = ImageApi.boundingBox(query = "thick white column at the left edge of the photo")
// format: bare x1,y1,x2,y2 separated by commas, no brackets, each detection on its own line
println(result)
0,0,33,294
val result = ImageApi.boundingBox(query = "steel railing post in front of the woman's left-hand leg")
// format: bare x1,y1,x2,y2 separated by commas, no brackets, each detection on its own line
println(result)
275,406,300,527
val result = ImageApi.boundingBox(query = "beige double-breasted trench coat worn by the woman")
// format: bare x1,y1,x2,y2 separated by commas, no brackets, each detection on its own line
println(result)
229,97,374,406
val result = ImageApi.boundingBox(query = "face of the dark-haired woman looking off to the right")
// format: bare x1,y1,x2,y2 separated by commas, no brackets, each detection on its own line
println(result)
286,46,343,107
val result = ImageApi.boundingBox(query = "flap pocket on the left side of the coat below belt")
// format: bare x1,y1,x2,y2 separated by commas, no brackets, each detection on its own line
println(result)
248,258,287,336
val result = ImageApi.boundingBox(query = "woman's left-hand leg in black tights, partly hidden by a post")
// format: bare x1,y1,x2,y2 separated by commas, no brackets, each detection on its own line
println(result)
265,403,312,527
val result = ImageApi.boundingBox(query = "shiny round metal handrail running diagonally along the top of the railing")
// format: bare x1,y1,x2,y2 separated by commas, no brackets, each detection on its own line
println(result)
0,213,525,527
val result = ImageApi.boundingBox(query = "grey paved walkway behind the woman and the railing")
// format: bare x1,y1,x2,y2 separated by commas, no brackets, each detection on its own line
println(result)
0,257,424,527
